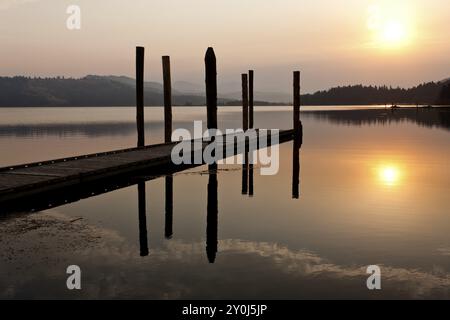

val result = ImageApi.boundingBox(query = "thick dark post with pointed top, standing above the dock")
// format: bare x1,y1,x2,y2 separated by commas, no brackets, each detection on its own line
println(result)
205,47,217,129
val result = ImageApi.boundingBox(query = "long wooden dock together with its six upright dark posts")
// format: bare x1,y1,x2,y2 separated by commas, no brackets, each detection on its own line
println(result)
0,47,303,213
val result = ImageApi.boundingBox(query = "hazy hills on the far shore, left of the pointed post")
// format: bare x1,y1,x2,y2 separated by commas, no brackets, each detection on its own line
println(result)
0,75,210,107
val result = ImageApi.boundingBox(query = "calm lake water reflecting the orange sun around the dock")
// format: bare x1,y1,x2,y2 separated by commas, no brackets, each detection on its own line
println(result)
0,107,450,299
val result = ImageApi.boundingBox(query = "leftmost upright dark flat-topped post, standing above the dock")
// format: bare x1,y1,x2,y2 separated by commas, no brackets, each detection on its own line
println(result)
136,47,145,147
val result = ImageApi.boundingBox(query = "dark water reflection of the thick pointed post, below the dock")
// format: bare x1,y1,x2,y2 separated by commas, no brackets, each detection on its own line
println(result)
206,164,219,263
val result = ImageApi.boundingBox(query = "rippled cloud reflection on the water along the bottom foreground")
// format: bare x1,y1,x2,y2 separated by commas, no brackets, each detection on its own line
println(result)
0,210,450,299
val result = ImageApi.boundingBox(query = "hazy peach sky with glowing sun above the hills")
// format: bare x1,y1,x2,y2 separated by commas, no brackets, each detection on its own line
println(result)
0,0,450,92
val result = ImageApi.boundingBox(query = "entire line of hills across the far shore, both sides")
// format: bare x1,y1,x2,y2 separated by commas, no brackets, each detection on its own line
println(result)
0,75,450,107
